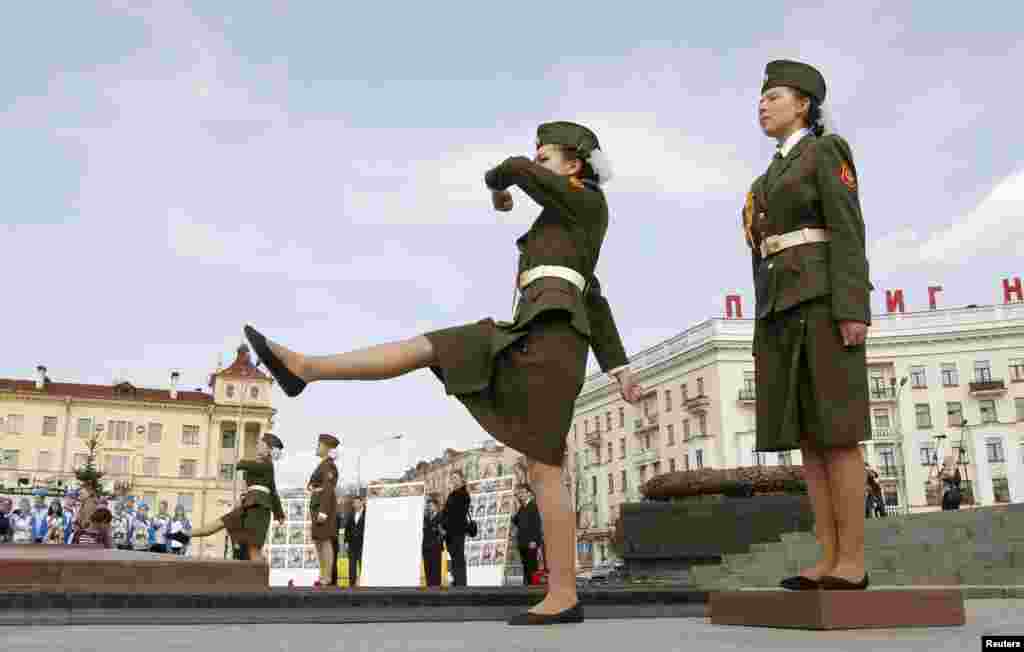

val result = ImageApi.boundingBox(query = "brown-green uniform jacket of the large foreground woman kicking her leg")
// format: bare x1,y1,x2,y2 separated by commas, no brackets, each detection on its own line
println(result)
484,157,629,372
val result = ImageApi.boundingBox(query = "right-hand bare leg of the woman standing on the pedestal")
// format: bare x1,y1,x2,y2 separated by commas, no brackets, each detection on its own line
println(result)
825,446,864,582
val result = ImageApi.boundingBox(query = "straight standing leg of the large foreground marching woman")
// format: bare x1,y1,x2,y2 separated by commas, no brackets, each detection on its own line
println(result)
529,454,579,615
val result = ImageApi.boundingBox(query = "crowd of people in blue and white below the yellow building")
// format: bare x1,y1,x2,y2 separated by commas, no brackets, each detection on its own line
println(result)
0,487,193,555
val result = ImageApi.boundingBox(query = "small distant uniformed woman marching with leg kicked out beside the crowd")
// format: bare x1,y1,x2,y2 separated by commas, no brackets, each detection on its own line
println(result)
178,433,285,561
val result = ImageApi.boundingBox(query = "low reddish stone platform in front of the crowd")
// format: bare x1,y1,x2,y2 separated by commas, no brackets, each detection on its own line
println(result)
0,545,270,593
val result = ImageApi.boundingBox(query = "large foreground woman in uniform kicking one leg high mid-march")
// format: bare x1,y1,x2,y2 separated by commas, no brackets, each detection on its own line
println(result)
246,122,641,624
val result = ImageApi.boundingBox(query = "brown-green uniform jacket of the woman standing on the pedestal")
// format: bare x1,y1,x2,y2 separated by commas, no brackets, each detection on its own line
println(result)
743,134,873,345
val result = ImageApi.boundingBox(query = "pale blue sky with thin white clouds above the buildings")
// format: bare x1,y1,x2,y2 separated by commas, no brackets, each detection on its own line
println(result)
0,0,1024,483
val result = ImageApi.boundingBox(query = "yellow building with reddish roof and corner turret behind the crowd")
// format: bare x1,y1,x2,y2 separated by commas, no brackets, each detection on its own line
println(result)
0,345,275,557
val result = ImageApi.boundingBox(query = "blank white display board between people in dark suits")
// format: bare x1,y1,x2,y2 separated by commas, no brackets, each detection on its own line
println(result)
359,482,426,586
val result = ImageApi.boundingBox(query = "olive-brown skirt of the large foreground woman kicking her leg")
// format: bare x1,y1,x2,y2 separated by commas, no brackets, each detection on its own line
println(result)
425,309,589,466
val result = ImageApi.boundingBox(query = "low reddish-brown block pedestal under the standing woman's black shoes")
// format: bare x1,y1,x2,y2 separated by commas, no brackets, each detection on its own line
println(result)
709,586,966,629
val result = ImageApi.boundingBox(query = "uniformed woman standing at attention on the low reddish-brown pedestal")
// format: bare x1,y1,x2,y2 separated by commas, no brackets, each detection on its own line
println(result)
743,60,872,590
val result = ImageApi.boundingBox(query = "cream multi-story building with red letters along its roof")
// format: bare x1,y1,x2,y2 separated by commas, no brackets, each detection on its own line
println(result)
567,292,1024,565
